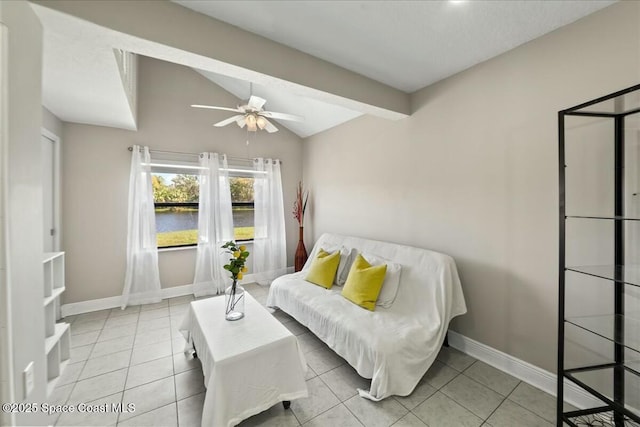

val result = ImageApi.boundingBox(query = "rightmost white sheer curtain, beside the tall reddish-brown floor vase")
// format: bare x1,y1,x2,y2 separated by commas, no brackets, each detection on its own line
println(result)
253,158,287,284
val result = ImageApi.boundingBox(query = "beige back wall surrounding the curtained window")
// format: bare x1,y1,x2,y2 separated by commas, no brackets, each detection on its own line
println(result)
62,57,302,303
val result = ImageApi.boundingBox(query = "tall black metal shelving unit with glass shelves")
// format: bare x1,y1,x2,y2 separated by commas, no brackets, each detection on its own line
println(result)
557,85,640,427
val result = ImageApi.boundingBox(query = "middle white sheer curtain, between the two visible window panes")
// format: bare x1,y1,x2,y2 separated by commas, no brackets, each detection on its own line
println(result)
193,153,238,297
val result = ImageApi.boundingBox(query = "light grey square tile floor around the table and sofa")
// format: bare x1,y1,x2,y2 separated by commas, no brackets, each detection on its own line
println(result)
49,284,555,427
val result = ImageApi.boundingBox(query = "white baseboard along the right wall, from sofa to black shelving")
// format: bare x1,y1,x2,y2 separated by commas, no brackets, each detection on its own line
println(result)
449,331,602,409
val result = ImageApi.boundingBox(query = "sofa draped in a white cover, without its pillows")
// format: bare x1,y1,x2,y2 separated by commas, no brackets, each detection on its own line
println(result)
267,234,467,401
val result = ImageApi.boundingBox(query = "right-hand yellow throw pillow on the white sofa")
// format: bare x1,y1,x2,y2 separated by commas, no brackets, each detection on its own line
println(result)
342,254,387,311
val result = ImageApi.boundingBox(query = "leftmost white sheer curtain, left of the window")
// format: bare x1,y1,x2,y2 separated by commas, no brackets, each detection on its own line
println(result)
121,145,161,309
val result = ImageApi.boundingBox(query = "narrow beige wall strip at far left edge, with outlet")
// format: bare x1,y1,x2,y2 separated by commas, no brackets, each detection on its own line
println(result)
0,2,46,425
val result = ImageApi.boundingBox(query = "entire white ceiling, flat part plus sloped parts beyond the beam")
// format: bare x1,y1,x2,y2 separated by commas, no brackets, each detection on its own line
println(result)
34,0,614,137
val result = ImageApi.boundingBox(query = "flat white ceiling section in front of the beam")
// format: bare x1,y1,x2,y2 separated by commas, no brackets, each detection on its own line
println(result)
173,0,614,92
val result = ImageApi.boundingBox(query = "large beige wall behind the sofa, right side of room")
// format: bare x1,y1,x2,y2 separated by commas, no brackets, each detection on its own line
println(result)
304,2,640,371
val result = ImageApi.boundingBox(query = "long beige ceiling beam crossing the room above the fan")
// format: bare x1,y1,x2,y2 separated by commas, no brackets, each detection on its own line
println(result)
32,0,411,120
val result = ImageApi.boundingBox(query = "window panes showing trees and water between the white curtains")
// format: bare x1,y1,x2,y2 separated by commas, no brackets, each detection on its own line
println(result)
152,166,254,248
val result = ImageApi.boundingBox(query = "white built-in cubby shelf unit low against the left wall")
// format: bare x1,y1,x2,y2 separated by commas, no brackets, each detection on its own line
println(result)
42,252,71,395
